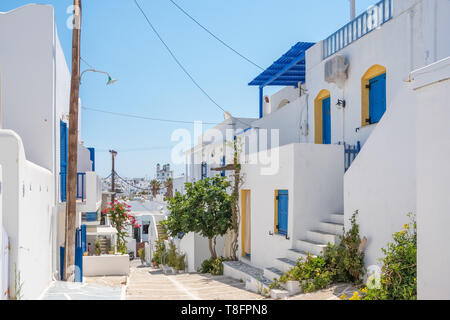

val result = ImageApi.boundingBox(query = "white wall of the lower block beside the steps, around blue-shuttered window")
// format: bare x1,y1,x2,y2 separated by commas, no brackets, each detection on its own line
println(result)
239,143,344,267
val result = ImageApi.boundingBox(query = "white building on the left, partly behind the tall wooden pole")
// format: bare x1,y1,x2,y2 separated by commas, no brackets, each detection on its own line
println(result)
0,5,101,299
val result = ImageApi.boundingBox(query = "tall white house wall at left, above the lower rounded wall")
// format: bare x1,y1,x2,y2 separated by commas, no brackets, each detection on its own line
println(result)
0,5,70,172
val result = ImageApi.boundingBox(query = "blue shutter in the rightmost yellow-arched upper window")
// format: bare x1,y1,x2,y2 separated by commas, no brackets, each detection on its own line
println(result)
369,74,386,123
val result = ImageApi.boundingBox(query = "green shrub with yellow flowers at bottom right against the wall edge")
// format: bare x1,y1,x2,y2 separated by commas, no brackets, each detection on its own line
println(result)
364,214,417,300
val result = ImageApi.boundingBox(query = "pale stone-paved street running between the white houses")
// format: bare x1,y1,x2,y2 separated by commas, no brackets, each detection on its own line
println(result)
42,260,355,300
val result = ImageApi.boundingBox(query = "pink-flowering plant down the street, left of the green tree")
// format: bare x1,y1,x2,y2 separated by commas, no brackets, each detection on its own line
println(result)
102,200,141,254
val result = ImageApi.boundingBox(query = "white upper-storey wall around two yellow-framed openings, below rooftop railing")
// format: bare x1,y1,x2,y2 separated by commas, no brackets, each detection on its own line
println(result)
306,0,450,148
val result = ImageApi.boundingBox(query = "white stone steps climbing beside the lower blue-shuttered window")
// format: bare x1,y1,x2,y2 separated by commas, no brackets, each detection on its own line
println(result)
263,214,344,280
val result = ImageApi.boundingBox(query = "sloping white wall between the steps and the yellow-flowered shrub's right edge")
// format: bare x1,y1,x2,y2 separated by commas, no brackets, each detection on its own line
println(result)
344,84,416,265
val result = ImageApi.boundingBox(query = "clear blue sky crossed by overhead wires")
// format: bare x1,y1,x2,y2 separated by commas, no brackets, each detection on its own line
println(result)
0,0,377,178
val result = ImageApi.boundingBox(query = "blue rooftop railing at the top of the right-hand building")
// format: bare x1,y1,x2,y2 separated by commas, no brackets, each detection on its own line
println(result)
323,0,394,59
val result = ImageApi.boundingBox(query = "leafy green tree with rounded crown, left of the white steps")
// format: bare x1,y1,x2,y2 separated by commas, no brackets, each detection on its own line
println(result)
163,176,232,259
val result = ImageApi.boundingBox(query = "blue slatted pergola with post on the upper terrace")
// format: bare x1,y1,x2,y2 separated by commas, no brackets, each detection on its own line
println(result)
248,42,314,118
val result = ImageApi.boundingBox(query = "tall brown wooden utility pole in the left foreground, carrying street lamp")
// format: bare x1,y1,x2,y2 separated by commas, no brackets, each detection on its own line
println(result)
63,0,81,281
